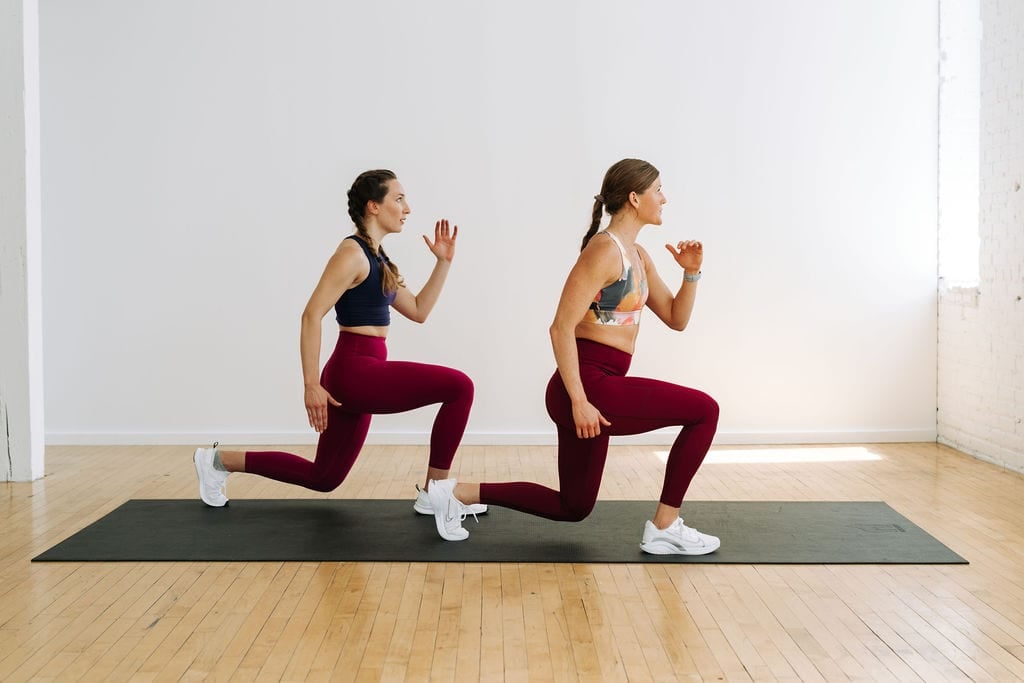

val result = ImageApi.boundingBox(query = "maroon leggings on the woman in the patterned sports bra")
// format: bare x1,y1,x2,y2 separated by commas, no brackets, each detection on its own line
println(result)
480,339,718,521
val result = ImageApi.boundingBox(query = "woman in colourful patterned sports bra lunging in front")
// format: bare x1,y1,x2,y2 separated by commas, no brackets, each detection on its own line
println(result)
430,159,720,555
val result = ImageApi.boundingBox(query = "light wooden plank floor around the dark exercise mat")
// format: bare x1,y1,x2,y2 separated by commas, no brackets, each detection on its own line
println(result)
0,443,1024,682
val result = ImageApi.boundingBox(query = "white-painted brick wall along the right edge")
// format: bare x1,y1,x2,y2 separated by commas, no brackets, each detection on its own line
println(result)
938,0,1024,471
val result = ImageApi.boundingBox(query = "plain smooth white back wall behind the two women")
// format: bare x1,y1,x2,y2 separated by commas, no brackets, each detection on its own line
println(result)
41,0,937,443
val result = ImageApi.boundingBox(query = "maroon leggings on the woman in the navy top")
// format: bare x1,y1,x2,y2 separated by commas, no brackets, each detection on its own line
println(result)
246,332,473,492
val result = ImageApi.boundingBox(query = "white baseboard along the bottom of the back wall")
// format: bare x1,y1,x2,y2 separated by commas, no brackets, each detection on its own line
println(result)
46,429,936,445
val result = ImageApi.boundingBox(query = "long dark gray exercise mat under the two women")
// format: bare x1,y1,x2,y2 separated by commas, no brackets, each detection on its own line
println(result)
33,499,967,564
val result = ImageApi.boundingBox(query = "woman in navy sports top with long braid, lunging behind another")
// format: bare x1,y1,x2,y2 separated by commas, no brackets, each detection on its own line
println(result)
194,170,485,533
